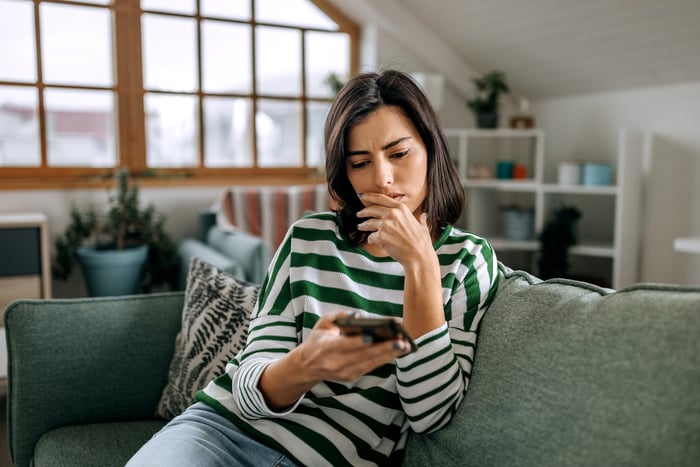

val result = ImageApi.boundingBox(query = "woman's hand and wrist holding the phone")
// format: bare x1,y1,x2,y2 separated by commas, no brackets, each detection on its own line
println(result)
258,312,410,411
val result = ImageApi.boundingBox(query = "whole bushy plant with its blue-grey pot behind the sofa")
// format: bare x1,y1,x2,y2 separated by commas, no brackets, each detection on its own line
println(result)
52,169,178,296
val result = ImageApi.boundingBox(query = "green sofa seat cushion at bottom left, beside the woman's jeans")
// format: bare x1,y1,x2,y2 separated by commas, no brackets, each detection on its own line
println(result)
33,420,165,467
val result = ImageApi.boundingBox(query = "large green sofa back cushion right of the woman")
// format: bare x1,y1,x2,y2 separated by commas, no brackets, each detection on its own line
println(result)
406,268,700,466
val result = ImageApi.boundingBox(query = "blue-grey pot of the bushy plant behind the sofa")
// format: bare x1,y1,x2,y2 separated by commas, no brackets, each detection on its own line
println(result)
77,245,148,297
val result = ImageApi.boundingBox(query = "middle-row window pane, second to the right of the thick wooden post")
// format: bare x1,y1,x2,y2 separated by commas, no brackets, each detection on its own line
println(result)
202,20,253,93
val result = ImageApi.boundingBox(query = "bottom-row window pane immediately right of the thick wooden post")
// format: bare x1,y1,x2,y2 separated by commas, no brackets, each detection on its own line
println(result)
144,94,199,167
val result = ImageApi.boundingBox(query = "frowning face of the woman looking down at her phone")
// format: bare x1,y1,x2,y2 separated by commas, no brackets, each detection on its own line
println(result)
345,106,428,217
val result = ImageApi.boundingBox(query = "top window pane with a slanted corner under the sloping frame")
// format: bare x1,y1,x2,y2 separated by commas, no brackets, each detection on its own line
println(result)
255,0,338,31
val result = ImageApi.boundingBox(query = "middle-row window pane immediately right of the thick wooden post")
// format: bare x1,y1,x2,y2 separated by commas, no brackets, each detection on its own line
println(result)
142,14,197,91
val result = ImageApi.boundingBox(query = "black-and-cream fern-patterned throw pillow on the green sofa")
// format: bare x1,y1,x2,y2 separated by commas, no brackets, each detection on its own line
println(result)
156,257,259,420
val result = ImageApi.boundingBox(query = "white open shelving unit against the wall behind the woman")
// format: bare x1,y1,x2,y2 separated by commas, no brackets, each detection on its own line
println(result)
445,128,645,288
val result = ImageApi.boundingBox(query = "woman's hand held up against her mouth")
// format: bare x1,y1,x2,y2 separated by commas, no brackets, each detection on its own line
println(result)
357,192,434,267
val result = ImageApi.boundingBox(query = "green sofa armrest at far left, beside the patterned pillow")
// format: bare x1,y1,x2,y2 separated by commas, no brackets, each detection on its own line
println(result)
5,292,184,466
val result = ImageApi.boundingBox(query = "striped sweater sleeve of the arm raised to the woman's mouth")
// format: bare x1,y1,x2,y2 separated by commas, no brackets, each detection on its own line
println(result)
396,241,498,433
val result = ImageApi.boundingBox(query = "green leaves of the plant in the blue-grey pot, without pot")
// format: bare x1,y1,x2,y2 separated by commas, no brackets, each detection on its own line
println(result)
52,169,178,292
